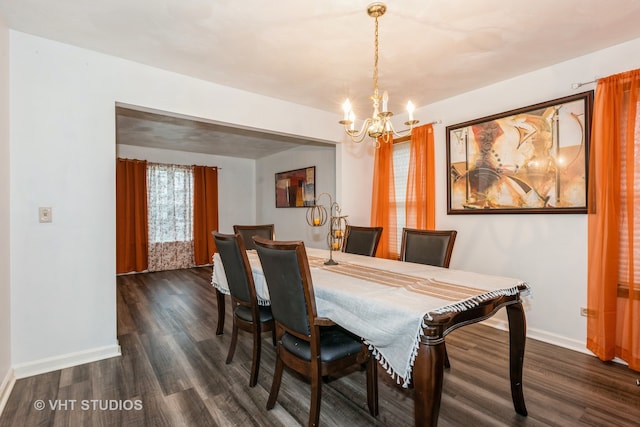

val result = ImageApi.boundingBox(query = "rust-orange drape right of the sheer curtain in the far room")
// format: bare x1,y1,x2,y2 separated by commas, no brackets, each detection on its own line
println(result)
193,166,218,265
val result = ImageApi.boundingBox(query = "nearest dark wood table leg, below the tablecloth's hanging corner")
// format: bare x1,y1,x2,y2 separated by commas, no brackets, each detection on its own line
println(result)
413,334,445,426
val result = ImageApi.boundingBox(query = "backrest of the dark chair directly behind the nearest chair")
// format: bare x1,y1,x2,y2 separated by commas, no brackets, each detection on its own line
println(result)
211,231,258,305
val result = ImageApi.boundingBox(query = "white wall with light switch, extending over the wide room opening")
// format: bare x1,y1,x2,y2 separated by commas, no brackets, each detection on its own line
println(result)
9,31,338,376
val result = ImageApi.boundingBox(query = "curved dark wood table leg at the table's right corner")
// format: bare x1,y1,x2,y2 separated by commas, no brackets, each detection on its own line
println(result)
507,303,527,416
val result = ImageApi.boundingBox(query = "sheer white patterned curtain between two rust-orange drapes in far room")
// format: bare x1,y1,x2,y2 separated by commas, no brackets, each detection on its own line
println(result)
147,163,194,271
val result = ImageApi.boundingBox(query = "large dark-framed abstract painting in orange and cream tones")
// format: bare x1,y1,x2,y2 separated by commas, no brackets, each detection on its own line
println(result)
446,91,593,214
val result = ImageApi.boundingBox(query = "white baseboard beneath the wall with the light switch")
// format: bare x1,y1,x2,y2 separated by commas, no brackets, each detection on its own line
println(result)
13,343,121,379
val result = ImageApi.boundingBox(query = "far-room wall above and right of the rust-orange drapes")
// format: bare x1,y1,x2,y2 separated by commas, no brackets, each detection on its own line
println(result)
117,144,256,233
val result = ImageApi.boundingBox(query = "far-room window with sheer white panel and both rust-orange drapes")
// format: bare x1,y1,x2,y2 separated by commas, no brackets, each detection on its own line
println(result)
116,158,218,274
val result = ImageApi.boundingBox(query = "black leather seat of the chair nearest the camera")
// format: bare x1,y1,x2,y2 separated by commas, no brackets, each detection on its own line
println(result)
282,326,362,362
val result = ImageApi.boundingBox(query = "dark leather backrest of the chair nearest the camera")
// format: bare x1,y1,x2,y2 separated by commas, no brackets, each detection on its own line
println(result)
253,237,317,337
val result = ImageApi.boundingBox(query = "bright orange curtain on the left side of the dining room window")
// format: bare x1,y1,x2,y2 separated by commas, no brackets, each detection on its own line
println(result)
371,140,400,259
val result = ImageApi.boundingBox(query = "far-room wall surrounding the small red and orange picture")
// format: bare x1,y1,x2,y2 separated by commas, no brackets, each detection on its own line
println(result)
256,145,336,248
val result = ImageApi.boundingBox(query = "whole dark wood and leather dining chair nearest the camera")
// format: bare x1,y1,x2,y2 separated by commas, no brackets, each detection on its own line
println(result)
254,237,378,426
